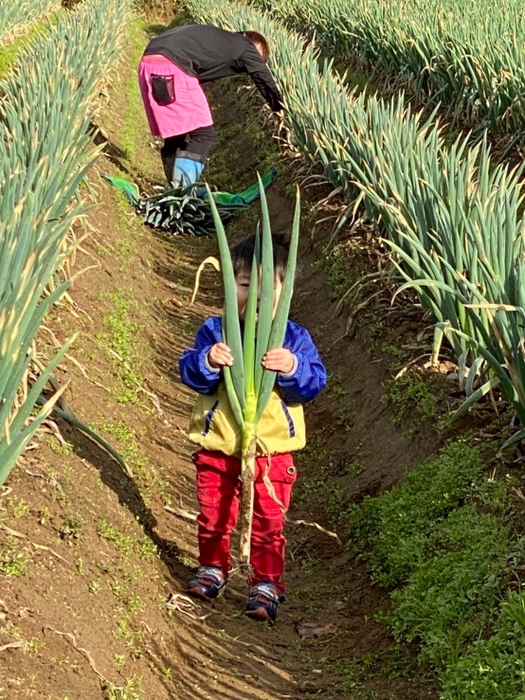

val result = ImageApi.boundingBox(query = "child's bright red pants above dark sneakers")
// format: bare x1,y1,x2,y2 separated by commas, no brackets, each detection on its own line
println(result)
193,450,297,591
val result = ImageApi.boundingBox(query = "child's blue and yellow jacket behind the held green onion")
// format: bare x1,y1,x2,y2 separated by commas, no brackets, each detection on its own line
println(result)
179,316,326,456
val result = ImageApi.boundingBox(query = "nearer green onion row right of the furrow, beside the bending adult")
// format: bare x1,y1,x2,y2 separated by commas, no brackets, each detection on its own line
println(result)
187,0,525,438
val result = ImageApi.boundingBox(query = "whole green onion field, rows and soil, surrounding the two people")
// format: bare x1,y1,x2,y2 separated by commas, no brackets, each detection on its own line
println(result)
0,0,525,700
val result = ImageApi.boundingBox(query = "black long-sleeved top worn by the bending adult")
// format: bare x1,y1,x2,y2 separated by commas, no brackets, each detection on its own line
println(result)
144,24,283,112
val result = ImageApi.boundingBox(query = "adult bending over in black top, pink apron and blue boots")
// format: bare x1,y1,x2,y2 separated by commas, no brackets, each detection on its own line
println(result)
139,24,283,187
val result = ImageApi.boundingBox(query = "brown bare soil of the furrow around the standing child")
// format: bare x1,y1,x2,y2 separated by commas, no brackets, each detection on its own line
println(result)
0,21,438,700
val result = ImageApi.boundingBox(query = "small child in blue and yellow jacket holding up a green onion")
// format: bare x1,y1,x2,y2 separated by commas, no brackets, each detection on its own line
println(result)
180,237,326,622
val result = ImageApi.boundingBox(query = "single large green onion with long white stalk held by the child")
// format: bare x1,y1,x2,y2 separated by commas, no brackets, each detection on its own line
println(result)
208,178,300,570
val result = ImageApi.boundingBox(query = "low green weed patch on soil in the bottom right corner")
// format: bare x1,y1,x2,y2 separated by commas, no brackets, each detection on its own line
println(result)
353,442,525,700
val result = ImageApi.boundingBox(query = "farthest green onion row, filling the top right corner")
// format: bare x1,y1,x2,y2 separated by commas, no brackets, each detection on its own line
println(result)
253,0,525,134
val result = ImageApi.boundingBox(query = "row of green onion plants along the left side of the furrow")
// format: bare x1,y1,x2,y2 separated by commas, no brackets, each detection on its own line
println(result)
0,0,129,484
